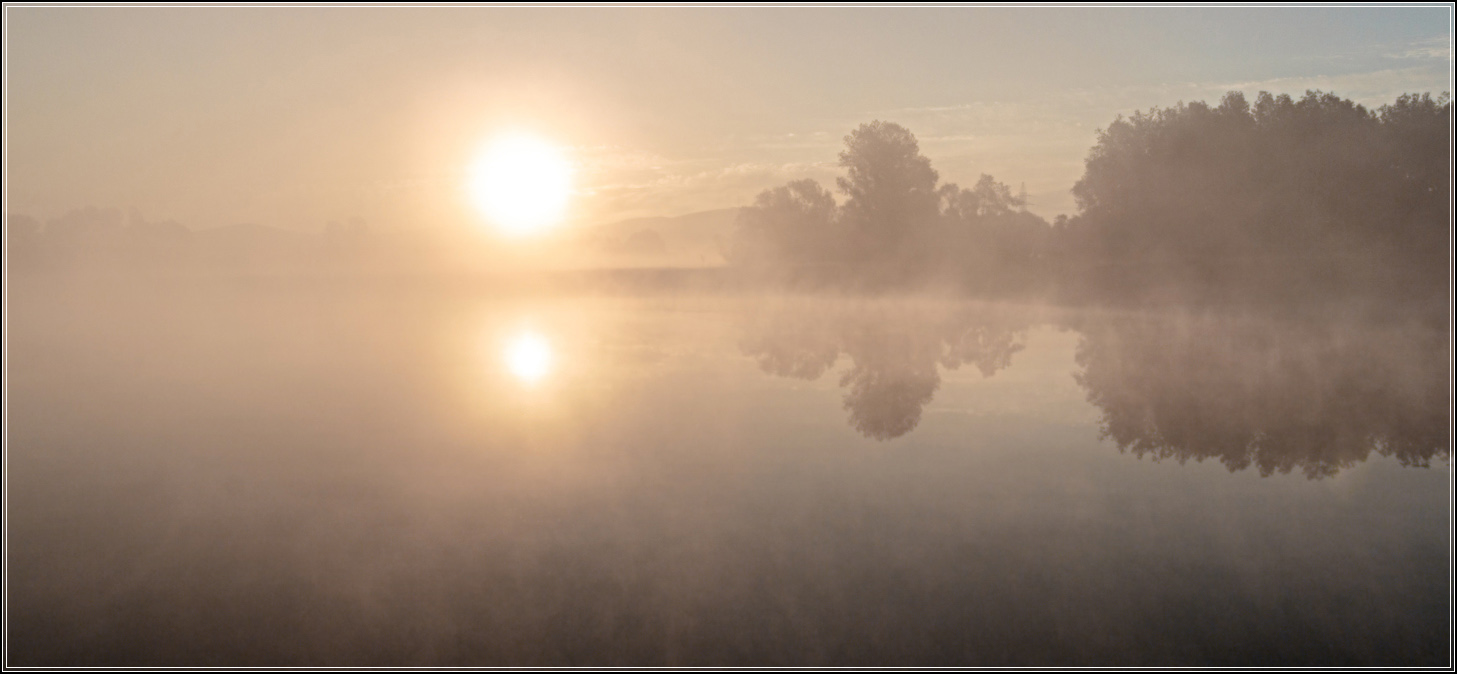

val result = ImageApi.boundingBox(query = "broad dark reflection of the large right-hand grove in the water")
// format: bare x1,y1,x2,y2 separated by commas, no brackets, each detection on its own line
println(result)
1075,316,1451,479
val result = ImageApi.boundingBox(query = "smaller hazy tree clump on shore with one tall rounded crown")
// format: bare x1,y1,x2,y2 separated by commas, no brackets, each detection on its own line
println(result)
729,121,1049,291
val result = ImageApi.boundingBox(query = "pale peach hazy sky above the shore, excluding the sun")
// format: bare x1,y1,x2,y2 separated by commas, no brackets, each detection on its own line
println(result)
4,6,1453,237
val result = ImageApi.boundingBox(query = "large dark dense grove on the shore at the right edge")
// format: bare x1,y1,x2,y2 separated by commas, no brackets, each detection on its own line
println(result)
1059,92,1451,307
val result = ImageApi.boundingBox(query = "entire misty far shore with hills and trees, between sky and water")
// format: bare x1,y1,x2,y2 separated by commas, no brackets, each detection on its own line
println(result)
6,92,1451,317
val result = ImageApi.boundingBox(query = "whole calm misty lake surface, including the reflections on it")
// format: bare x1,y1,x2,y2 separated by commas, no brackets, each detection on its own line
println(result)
6,284,1453,665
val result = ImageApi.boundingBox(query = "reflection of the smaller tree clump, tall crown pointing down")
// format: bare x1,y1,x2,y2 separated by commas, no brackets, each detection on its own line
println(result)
740,306,1030,440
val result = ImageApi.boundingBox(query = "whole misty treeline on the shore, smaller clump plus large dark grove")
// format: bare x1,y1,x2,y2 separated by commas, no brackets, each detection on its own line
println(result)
729,92,1451,303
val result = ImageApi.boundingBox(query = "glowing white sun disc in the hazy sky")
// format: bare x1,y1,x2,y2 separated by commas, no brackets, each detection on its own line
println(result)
466,134,571,234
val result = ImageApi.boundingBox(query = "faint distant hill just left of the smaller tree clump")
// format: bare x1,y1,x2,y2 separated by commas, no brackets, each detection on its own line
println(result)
581,208,740,266
